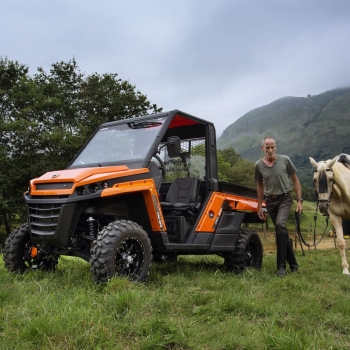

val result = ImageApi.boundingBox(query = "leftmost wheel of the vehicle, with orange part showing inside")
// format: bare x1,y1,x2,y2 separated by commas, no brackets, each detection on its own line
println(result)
3,224,58,273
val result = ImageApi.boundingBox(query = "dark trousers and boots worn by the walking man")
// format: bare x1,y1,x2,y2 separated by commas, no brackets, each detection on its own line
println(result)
265,193,298,269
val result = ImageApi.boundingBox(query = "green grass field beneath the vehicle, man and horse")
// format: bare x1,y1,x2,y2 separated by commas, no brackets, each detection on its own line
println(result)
0,249,350,350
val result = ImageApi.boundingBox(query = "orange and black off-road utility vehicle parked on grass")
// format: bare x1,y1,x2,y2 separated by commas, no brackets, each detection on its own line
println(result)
3,110,263,282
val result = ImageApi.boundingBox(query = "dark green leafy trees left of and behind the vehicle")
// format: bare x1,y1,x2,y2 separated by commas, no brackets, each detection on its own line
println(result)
0,58,161,233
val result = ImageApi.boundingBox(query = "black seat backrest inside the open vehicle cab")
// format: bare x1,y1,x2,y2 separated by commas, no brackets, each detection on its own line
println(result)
165,177,200,204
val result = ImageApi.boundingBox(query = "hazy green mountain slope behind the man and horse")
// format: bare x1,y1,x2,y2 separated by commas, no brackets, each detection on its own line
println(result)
218,88,350,186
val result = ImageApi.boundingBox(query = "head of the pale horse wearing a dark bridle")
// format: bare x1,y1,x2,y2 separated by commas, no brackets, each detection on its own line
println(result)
309,156,338,215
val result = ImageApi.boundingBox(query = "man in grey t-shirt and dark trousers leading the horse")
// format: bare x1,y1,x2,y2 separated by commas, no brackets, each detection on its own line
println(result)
254,136,303,277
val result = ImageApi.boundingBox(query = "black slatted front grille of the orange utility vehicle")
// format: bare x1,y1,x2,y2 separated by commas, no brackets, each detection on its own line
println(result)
28,204,61,235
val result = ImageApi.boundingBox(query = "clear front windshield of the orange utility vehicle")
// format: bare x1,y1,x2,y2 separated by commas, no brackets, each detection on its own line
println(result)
70,118,162,166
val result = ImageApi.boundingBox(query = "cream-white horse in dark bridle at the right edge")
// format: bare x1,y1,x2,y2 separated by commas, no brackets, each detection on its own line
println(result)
309,154,350,276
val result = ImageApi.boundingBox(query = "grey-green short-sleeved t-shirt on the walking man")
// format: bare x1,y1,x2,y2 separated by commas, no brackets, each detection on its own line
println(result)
254,155,297,196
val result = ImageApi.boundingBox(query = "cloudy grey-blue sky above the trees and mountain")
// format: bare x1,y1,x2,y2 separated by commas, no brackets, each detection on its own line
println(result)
0,0,350,137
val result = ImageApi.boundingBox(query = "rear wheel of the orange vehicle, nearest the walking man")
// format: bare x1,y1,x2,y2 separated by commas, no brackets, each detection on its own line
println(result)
224,230,263,273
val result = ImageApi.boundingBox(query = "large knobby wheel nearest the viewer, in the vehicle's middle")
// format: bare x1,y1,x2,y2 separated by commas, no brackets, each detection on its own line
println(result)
90,220,152,282
